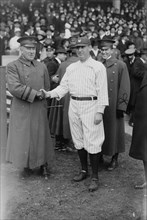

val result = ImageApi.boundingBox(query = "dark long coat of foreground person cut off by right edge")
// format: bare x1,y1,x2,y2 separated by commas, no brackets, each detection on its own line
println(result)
129,71,147,162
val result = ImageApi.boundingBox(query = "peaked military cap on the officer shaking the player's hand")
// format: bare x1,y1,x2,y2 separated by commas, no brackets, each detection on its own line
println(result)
17,36,38,46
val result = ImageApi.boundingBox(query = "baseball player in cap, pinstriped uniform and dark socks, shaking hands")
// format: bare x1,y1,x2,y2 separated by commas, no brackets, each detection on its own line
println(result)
41,37,108,192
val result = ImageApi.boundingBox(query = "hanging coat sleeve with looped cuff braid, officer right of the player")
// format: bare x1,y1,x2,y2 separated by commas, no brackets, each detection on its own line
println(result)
117,62,130,111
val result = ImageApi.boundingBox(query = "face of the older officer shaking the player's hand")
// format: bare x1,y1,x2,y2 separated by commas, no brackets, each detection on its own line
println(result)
21,45,36,61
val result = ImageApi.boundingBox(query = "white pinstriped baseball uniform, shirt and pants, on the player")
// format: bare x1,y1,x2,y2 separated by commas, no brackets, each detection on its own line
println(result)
50,57,108,154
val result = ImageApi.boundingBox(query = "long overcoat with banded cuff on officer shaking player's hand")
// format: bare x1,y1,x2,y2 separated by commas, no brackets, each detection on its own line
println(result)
6,57,54,169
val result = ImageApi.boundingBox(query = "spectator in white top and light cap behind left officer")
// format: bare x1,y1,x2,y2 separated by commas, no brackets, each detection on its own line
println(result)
9,28,21,55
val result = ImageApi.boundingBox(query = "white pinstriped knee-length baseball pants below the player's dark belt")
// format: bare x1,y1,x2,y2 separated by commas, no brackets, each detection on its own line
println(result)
68,99,105,154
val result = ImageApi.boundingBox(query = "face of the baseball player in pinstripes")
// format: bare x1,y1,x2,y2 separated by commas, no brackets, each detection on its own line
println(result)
76,45,90,61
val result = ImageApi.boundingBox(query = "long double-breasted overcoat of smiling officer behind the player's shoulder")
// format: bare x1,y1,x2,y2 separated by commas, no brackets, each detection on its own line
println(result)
102,57,130,156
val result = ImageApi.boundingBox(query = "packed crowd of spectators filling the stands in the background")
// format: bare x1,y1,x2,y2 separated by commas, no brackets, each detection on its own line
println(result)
0,0,147,64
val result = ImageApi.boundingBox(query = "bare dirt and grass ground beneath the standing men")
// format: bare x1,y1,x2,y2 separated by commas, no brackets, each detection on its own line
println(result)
1,121,147,220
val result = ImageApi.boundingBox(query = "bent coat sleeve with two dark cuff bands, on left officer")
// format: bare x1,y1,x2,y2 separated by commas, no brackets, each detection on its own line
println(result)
6,63,37,103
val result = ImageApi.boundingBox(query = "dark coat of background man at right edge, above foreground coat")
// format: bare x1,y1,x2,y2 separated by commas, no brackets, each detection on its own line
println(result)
129,57,147,107
